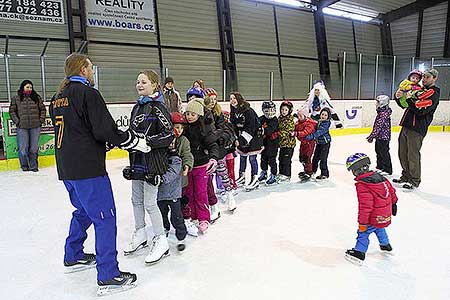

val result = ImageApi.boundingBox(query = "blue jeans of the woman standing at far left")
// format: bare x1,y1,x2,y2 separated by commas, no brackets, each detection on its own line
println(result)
17,127,41,170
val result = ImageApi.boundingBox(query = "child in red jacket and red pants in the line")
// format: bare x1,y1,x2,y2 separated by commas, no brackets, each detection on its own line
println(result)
293,105,317,182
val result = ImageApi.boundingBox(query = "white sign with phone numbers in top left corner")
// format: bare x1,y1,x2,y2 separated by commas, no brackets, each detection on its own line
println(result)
0,0,64,24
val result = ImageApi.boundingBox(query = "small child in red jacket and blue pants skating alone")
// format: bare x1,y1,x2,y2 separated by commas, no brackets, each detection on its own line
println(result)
345,153,398,265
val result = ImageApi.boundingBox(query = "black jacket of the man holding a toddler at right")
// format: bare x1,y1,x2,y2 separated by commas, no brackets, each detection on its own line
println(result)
396,86,441,136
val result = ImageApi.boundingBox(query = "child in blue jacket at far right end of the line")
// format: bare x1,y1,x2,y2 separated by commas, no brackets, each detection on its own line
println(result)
305,107,331,180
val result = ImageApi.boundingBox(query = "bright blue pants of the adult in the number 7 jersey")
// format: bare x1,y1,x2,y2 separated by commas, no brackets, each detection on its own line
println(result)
64,176,120,280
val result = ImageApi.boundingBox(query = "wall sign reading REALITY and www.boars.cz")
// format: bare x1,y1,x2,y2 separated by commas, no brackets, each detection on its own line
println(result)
86,0,155,32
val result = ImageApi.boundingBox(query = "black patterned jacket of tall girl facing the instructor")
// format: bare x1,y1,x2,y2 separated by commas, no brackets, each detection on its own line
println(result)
130,100,175,180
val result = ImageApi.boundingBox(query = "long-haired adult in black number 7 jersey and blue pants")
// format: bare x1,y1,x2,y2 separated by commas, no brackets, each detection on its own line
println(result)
50,53,150,291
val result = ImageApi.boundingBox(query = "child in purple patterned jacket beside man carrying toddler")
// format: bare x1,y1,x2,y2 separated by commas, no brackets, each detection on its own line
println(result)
367,95,392,175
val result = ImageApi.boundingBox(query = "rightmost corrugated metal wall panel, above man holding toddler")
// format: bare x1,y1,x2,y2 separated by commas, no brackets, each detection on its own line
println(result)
420,1,448,57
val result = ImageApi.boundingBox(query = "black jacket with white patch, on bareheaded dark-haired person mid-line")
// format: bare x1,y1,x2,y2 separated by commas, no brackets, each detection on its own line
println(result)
230,107,263,153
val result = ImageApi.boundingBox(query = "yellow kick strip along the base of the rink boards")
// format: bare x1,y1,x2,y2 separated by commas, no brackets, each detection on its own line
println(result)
0,126,450,172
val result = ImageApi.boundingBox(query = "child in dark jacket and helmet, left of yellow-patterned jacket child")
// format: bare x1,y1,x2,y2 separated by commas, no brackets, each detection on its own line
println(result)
258,101,278,185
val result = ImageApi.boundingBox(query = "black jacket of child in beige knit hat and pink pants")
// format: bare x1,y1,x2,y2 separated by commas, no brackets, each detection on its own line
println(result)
183,116,221,167
